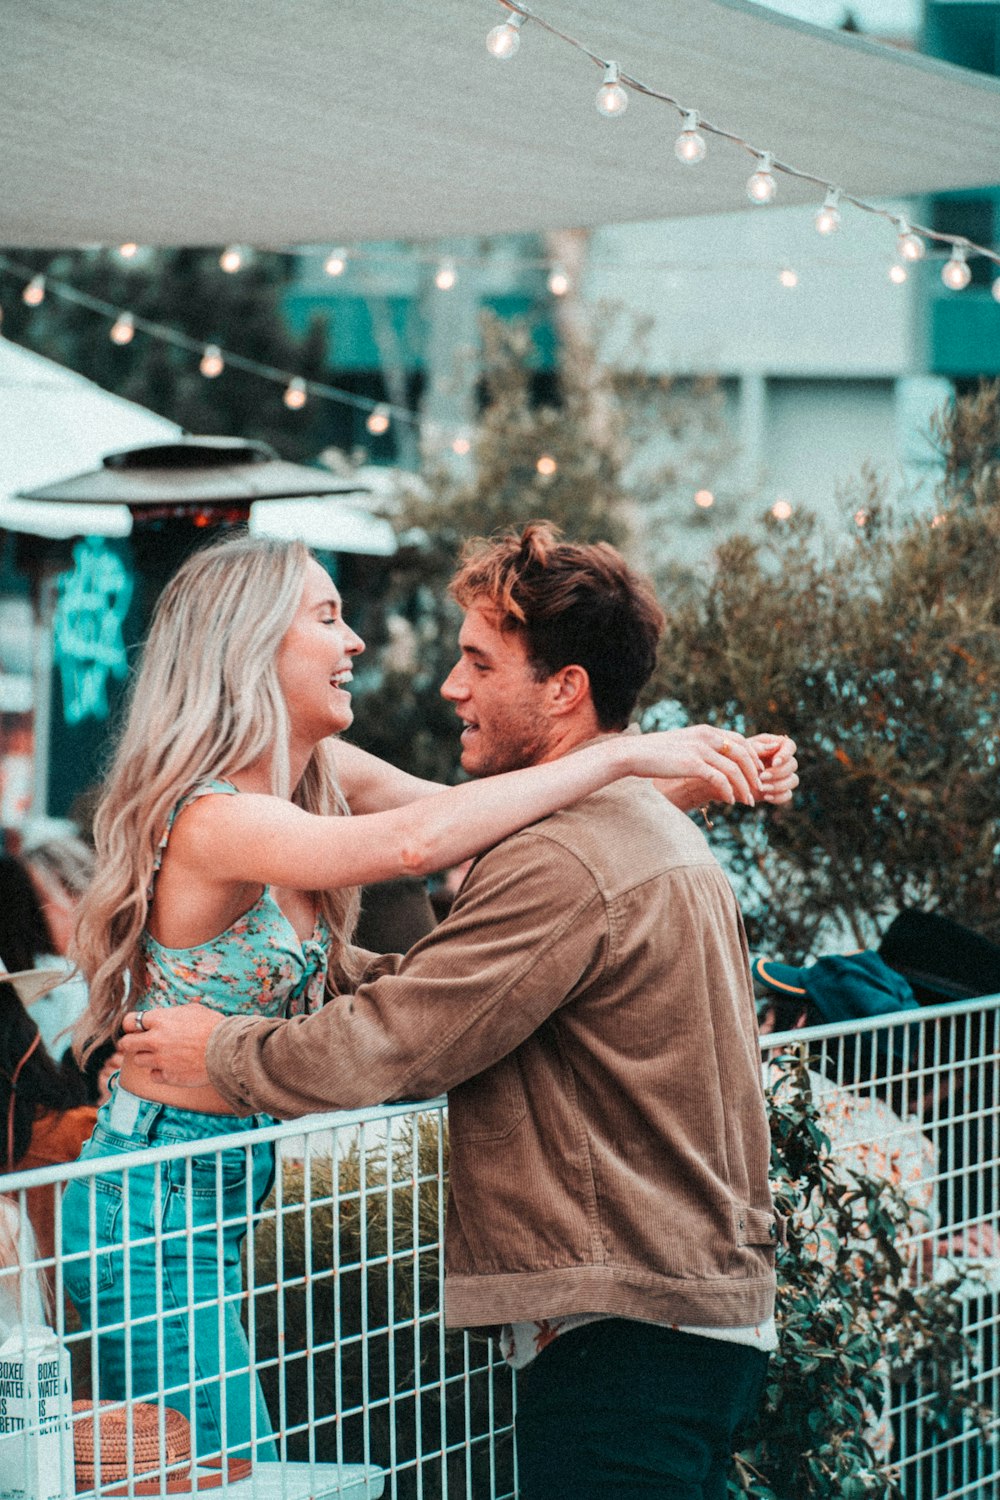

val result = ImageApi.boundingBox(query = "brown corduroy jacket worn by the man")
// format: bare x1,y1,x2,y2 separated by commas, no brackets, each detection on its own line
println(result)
208,780,778,1328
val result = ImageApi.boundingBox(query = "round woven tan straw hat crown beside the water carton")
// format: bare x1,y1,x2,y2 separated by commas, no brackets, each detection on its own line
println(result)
73,1401,190,1490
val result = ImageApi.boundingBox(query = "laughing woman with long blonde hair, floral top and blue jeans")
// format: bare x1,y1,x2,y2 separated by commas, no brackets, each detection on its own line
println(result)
63,537,779,1458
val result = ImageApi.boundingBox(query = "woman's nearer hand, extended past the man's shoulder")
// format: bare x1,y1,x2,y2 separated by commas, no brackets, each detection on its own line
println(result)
625,725,765,812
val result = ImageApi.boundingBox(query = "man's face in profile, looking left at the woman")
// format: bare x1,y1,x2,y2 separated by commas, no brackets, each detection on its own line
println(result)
441,608,560,776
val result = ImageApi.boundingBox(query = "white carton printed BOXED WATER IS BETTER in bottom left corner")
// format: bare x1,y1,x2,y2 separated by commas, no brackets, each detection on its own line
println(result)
0,1325,75,1500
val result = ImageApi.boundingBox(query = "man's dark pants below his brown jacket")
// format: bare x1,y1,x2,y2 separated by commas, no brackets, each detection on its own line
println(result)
516,1319,768,1500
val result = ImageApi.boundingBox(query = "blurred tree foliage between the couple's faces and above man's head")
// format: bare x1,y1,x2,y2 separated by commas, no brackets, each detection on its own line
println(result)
352,317,729,780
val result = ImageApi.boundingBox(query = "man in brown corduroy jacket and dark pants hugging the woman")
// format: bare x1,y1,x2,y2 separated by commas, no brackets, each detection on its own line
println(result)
124,524,796,1500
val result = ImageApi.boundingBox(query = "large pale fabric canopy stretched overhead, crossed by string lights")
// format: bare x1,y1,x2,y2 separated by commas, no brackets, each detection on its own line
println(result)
0,0,1000,246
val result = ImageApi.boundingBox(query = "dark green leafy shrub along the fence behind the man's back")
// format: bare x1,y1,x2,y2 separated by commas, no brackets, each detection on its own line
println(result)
730,1046,988,1500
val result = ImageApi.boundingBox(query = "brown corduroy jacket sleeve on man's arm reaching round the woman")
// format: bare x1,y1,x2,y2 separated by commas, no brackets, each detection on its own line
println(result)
207,830,609,1119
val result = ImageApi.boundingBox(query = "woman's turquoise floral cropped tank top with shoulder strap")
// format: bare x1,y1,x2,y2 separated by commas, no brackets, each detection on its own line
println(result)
135,782,330,1016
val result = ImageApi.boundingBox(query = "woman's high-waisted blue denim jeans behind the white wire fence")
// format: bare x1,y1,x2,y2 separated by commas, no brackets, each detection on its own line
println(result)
63,1086,277,1461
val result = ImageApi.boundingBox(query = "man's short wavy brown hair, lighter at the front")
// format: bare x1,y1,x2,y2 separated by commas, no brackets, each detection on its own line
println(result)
451,521,664,729
